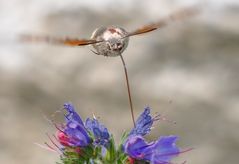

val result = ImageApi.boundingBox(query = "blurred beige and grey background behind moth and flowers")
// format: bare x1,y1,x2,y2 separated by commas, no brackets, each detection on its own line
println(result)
0,0,239,164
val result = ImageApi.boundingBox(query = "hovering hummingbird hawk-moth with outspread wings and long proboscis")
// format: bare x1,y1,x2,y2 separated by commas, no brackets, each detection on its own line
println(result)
21,7,199,126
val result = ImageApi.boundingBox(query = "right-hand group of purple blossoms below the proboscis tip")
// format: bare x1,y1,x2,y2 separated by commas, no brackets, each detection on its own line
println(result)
123,107,190,164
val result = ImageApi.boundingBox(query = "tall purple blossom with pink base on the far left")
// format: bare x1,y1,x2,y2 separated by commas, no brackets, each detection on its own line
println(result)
57,103,91,147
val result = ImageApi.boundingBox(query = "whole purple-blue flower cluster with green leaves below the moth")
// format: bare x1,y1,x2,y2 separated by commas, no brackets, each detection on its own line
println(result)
45,103,189,164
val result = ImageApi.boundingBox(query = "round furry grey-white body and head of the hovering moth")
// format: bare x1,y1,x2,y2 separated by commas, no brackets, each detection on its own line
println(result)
91,26,129,56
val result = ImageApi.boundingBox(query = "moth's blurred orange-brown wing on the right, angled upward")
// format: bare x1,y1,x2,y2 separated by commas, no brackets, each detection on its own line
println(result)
127,7,199,37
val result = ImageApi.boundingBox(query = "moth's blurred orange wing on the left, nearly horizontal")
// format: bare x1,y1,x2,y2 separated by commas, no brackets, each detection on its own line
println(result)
20,35,101,46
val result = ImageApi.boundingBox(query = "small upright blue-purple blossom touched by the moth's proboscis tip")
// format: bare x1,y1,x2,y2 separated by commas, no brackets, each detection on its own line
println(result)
129,107,159,136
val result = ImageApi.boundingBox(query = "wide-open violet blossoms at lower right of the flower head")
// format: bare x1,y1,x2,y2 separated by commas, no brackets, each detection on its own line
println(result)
124,135,181,164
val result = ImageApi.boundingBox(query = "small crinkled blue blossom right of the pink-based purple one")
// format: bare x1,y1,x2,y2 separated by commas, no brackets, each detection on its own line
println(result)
85,118,110,146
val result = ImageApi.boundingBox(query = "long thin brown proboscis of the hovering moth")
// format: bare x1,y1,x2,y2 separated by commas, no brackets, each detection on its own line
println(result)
120,54,135,127
